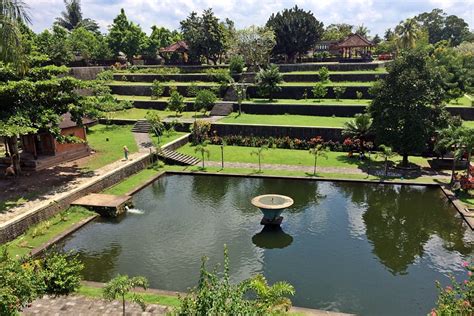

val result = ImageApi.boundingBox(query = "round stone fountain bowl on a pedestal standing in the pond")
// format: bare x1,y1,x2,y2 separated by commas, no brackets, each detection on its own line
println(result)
251,194,294,225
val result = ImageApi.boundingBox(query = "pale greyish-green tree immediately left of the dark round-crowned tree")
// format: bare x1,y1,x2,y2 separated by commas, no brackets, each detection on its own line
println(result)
235,25,276,68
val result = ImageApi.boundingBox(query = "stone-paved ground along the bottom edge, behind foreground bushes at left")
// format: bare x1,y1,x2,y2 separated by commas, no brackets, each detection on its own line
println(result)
21,295,171,316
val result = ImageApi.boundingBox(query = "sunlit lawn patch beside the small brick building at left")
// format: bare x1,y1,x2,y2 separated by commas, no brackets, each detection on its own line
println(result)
84,124,138,170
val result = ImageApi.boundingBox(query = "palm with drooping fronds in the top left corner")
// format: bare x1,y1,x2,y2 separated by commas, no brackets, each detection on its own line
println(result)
0,0,31,73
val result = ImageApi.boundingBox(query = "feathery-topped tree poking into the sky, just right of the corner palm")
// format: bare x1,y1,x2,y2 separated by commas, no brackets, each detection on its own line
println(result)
56,0,99,32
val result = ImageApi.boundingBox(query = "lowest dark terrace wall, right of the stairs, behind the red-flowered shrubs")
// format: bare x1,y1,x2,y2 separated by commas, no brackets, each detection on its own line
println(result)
211,124,344,141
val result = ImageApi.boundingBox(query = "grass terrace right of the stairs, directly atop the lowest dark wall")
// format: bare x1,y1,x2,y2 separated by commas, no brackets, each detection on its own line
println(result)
219,113,352,127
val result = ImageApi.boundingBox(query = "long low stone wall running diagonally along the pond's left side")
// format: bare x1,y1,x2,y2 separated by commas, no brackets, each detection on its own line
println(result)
0,155,153,244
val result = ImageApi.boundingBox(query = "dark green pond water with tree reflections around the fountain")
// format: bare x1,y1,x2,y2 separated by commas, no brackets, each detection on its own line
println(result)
60,175,474,315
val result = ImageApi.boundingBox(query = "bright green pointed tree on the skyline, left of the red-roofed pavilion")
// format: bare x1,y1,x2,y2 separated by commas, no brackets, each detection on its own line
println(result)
109,8,146,61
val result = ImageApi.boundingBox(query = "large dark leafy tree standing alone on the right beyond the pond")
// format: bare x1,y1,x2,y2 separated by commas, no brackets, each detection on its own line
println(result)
369,50,449,166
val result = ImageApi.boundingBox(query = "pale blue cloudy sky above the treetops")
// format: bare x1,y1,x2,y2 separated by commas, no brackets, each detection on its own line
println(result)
24,0,474,36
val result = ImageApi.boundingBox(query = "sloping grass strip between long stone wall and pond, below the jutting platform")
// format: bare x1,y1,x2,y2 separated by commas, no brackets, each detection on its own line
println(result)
7,206,95,258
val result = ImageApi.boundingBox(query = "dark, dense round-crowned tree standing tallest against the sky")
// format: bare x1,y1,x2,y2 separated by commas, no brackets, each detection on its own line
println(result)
266,5,324,62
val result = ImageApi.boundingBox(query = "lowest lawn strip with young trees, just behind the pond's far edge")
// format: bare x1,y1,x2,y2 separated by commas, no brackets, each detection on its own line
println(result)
178,144,429,169
